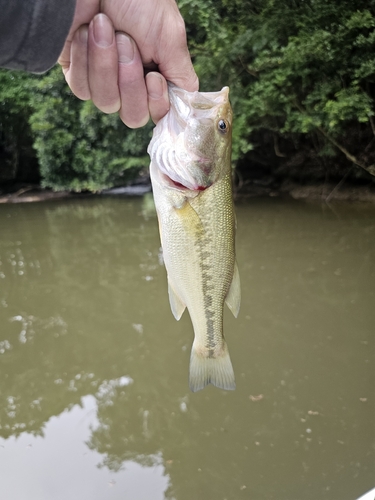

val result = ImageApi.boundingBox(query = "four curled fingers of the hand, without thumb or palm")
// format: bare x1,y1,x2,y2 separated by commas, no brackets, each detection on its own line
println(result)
63,14,169,128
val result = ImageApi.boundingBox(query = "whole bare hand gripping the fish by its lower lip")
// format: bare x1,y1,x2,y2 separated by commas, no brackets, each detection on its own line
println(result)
59,0,198,128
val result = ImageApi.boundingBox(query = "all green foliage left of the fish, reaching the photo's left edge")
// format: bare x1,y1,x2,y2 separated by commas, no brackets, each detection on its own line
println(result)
0,67,152,191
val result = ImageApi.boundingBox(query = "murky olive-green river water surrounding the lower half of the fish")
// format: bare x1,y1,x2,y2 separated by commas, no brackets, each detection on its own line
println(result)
0,197,375,500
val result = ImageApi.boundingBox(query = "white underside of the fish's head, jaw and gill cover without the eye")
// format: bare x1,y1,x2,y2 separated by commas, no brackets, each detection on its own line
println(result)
148,83,229,193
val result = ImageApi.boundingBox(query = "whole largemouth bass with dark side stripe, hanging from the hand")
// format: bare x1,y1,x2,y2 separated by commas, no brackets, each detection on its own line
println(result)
147,84,241,392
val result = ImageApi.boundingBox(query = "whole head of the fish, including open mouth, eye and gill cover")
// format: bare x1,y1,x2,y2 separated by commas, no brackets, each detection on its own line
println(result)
148,84,232,191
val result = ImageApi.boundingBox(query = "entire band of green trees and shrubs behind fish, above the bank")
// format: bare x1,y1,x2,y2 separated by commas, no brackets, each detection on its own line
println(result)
0,0,375,195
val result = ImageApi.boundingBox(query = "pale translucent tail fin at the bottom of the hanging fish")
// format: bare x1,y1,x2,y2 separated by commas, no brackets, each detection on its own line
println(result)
189,340,236,392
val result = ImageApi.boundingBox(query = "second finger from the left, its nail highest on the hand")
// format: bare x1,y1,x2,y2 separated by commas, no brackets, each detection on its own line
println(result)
88,14,121,113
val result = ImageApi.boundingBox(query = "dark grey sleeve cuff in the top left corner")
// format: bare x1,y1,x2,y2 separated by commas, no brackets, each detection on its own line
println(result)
0,0,76,73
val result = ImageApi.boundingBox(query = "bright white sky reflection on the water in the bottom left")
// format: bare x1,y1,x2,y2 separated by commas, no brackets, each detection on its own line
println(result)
0,396,168,500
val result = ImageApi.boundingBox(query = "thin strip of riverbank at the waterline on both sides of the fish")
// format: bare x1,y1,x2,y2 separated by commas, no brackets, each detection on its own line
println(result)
0,181,375,204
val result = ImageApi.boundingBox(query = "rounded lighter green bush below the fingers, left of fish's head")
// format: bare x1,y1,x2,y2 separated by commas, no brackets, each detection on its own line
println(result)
30,68,150,191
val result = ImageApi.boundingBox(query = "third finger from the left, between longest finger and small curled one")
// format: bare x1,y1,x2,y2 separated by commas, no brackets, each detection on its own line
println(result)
116,33,150,128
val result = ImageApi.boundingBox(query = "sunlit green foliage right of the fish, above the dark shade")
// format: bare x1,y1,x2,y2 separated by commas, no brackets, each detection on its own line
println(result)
180,0,375,175
